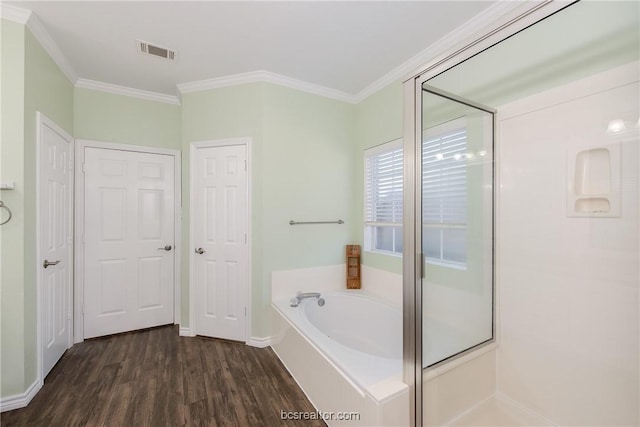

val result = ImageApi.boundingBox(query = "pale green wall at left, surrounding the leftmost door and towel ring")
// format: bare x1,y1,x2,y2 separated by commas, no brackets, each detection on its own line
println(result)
0,20,73,396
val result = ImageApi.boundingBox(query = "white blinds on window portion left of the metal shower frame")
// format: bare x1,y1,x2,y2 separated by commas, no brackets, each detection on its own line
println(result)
365,141,403,226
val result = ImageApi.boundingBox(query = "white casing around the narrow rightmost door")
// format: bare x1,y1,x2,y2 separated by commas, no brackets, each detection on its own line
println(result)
186,137,252,344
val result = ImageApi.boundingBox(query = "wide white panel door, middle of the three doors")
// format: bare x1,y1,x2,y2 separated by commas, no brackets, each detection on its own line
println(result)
84,147,175,338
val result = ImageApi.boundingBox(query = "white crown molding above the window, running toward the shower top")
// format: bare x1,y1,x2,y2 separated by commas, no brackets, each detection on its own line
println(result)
355,0,523,103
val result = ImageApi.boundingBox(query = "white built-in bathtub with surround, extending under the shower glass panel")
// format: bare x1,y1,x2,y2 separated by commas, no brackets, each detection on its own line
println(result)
270,264,496,427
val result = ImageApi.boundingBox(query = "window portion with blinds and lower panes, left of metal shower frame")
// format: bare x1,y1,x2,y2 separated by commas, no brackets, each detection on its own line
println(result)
364,139,403,254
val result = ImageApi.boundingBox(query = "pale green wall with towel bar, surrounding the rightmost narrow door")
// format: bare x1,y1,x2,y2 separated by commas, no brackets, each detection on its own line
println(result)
181,83,355,337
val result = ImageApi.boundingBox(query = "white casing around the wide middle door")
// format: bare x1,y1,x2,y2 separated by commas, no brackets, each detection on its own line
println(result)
74,139,182,343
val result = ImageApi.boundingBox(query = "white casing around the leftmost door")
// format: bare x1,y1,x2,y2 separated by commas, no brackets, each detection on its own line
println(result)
35,111,75,389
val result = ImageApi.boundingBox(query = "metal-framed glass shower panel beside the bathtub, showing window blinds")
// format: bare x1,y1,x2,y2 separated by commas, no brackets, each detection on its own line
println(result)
419,84,495,369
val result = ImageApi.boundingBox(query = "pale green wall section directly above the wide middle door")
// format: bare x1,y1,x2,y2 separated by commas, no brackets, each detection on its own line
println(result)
73,88,182,149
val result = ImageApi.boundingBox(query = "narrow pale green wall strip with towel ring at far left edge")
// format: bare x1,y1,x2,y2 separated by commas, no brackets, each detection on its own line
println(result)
0,20,26,396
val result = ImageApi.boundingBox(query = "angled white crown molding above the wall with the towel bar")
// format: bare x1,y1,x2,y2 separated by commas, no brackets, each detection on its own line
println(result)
178,70,357,104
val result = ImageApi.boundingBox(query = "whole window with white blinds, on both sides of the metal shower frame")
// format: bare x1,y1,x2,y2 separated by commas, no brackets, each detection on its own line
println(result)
364,119,468,268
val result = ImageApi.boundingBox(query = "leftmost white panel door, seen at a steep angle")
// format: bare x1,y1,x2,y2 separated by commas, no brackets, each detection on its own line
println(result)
38,115,73,379
